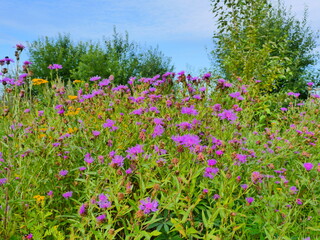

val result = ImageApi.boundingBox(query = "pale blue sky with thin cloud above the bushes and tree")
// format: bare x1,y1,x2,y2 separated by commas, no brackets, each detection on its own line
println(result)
0,0,320,73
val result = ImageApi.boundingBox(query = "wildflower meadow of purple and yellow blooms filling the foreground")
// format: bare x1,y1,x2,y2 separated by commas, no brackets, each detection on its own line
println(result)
0,46,320,240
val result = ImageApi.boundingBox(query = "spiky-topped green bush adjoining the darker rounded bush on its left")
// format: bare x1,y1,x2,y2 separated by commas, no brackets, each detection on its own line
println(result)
72,30,173,84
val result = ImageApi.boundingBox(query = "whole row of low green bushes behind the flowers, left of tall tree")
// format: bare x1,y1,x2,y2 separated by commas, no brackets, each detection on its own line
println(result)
29,30,173,84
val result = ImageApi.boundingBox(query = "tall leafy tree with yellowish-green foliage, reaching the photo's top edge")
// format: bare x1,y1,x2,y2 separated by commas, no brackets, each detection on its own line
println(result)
211,0,318,92
